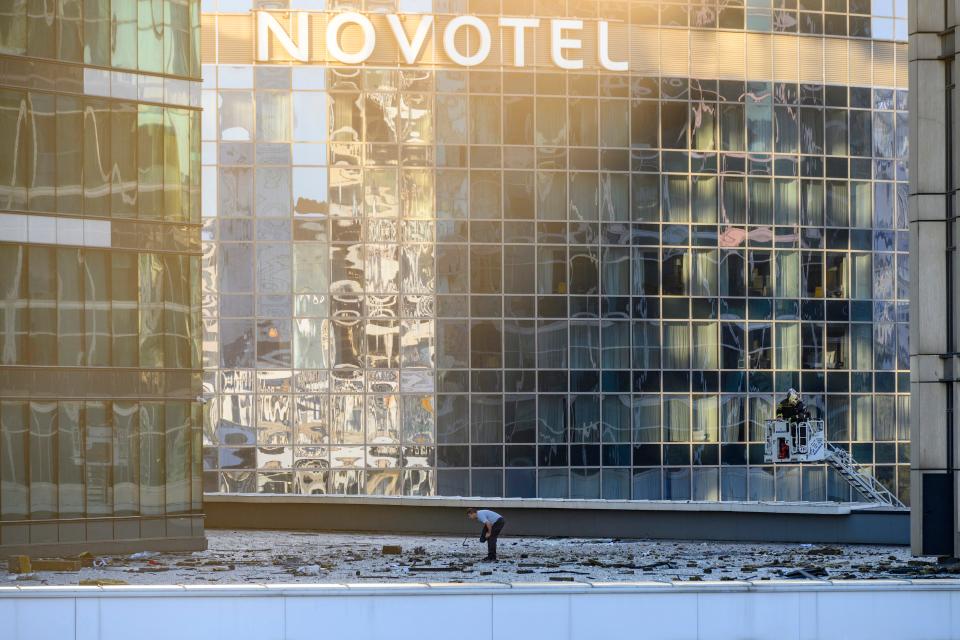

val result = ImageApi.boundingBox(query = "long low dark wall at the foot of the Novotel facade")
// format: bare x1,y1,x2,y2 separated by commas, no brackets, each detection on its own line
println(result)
204,495,909,544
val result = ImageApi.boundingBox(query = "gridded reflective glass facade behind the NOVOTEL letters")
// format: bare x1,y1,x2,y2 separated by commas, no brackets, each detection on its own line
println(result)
202,0,910,508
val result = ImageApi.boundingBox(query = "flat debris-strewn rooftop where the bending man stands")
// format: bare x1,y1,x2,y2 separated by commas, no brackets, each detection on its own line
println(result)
0,528,960,586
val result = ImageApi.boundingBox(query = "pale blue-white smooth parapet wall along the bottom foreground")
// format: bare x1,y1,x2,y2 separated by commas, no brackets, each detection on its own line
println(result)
0,580,960,640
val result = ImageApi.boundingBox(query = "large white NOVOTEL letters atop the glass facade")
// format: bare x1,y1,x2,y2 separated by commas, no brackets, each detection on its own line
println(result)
254,11,629,71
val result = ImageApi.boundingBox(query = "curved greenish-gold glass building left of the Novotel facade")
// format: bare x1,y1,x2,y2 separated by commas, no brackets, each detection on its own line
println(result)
0,0,206,553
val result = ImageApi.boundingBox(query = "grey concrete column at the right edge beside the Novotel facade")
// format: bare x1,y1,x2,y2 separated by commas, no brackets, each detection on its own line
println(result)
909,0,960,555
